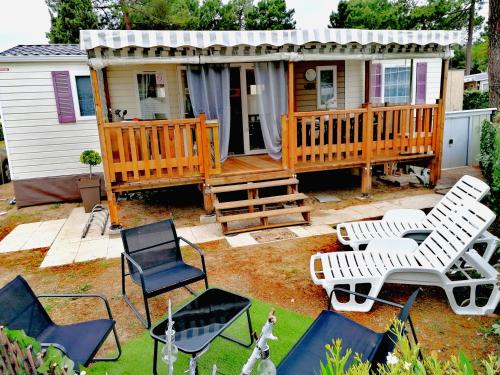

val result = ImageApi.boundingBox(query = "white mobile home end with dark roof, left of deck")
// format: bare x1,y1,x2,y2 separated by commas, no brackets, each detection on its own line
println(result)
0,44,102,207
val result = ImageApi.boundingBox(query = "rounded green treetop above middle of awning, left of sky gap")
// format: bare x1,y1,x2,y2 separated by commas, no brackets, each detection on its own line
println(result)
245,0,295,30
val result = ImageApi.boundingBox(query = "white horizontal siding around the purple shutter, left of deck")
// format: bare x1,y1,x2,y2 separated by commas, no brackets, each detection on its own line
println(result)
0,61,102,181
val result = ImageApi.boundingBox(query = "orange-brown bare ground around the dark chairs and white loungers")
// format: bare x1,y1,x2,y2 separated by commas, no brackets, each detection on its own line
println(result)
0,235,500,358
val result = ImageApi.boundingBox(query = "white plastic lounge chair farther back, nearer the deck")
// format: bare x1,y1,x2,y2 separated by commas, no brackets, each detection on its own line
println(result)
337,175,499,261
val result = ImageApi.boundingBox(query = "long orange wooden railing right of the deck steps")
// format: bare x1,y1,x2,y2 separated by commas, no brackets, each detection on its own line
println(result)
282,104,440,168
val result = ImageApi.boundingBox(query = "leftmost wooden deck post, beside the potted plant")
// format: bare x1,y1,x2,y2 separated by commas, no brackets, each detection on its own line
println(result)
90,69,120,226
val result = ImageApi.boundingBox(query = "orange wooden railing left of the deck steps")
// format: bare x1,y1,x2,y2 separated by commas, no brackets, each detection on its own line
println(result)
103,114,220,182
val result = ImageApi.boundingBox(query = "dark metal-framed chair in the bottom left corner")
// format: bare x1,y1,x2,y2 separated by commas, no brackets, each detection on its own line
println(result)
0,276,121,368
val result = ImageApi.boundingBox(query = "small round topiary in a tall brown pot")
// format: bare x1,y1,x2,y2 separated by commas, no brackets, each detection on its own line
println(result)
78,150,102,212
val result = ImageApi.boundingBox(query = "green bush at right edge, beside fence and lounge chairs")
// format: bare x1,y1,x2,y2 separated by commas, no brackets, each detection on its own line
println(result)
479,120,500,235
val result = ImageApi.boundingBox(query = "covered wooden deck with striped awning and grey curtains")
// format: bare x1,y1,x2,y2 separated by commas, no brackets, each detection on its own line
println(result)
80,29,463,230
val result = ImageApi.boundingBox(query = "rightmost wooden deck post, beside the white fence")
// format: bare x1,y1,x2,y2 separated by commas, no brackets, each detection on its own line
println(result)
430,59,450,185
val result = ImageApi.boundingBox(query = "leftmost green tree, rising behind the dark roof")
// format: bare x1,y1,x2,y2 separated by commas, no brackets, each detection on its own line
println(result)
47,0,99,43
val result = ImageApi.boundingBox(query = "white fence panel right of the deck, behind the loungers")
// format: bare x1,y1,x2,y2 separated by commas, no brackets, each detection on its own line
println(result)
441,108,495,169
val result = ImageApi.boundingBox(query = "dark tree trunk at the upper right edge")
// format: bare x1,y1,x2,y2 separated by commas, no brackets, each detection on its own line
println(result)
488,0,500,109
